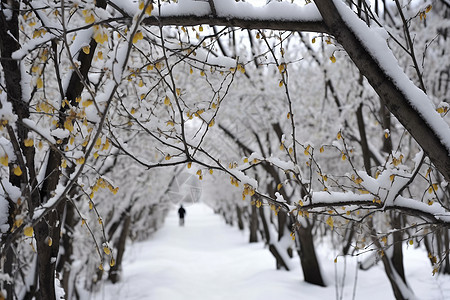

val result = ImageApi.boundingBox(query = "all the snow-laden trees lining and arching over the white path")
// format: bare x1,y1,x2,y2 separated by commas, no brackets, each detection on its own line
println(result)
0,0,450,299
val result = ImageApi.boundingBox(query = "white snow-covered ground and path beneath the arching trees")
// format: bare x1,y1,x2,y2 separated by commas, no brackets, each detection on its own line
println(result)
91,203,450,300
